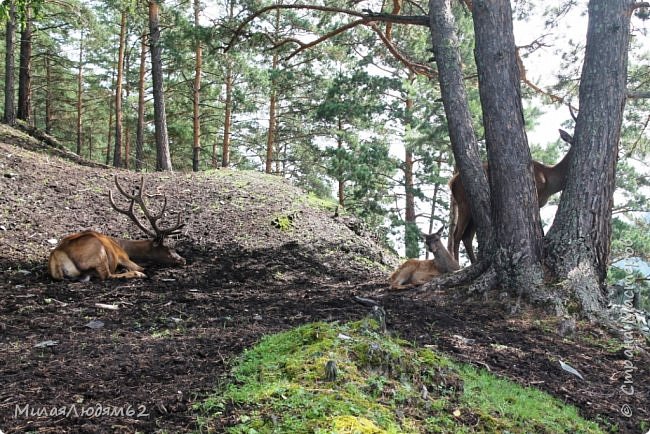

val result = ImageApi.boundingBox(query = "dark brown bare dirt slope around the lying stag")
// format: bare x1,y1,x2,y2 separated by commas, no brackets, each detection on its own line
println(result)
0,131,650,433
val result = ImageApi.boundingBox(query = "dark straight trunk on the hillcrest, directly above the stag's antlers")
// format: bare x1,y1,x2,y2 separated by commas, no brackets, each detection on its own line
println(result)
149,0,172,170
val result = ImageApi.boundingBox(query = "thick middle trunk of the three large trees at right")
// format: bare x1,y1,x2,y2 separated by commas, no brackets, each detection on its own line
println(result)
472,0,543,296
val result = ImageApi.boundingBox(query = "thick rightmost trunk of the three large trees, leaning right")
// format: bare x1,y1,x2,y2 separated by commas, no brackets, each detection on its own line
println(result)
546,0,634,314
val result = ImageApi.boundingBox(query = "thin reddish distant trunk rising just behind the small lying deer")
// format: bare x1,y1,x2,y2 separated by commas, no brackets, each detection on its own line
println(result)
404,86,420,258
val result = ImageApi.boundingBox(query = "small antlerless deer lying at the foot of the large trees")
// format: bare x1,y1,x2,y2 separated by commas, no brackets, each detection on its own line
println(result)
390,228,460,289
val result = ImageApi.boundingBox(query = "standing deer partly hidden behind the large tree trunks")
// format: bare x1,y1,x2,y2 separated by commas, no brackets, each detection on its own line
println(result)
448,130,573,262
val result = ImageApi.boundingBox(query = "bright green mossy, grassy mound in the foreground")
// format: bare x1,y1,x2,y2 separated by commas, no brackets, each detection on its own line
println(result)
195,320,602,434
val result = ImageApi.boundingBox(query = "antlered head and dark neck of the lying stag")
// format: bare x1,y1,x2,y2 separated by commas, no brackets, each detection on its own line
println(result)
108,175,185,265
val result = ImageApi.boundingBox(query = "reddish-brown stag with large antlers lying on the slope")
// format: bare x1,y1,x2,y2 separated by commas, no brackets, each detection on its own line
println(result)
48,176,185,280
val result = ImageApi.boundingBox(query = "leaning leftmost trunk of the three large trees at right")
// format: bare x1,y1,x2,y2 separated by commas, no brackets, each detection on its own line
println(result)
429,0,493,259
